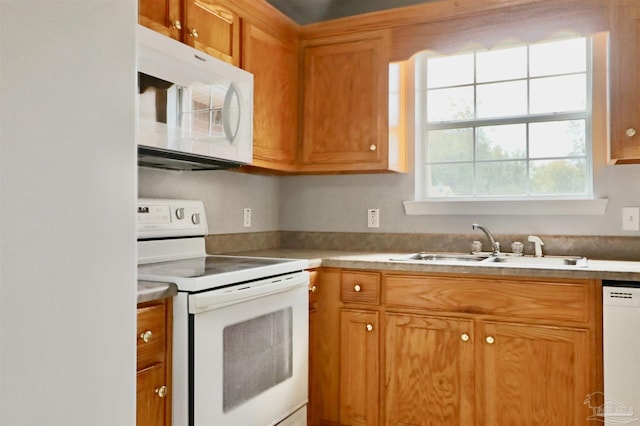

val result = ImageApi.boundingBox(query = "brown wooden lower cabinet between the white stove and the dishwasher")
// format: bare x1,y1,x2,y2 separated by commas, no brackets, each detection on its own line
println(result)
310,268,602,426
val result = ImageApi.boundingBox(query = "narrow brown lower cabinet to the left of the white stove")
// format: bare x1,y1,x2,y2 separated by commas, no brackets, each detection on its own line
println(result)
136,298,173,426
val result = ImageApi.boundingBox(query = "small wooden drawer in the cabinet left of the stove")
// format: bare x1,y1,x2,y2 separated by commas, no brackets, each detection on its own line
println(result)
136,303,167,370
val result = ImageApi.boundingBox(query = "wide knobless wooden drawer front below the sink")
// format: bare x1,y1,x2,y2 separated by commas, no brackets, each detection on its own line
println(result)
385,275,593,322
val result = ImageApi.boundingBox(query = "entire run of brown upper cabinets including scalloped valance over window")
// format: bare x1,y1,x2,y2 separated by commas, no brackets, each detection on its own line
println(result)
139,0,640,173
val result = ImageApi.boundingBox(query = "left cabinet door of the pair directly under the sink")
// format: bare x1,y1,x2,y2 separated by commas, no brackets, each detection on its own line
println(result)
385,314,472,426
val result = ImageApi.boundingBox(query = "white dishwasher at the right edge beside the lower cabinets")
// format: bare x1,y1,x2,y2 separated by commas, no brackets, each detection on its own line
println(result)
600,281,640,426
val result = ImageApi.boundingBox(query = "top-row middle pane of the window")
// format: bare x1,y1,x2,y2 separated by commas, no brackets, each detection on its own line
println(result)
476,46,527,83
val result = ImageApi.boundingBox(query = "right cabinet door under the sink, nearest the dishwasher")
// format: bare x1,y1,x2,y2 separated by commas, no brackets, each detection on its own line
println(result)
478,322,596,426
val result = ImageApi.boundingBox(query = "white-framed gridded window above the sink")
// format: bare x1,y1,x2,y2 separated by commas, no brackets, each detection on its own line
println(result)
415,37,593,200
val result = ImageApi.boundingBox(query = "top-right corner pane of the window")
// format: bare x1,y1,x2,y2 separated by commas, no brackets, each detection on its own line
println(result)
530,38,587,77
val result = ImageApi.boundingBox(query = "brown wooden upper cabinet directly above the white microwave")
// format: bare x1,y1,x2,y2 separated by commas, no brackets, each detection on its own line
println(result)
138,0,240,65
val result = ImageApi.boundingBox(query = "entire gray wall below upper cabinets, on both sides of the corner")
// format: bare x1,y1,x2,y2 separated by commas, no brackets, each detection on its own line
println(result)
139,160,640,236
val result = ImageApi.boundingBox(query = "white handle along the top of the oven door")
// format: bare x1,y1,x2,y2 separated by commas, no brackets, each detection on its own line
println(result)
189,271,309,314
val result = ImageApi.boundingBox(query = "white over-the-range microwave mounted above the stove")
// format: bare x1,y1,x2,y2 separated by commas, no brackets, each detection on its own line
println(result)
136,25,253,170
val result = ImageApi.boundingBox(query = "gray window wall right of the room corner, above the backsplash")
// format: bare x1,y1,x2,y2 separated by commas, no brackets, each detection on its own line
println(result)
280,166,640,236
